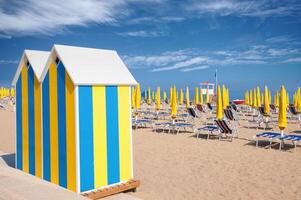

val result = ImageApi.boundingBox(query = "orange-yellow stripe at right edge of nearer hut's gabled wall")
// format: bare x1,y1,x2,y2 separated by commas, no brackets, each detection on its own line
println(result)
65,72,76,192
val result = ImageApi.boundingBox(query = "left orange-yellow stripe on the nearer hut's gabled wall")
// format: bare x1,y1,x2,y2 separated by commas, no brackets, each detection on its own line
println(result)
49,63,59,184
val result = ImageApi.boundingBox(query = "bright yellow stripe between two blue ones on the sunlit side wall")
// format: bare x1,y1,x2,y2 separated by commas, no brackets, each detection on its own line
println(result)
92,86,108,188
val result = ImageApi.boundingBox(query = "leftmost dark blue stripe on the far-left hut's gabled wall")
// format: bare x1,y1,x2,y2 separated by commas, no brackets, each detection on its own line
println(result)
16,75,22,170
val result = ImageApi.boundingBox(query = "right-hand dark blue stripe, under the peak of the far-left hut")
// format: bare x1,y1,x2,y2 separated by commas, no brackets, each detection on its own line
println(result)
28,66,35,175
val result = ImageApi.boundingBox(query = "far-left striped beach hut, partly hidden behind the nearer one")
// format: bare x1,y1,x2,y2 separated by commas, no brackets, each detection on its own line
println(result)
12,50,49,177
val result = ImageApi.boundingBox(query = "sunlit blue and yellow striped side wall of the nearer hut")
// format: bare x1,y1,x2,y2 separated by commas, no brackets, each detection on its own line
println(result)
78,86,132,192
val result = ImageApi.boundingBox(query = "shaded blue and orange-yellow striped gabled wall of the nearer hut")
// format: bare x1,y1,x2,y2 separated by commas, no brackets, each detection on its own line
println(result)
42,62,76,191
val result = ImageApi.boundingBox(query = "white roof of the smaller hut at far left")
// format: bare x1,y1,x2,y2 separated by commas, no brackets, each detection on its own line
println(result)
12,49,49,85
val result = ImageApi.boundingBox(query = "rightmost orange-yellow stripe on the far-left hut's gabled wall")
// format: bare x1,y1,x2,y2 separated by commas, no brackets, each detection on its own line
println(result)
34,77,42,177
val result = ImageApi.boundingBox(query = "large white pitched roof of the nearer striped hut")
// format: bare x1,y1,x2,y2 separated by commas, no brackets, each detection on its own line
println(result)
41,45,137,85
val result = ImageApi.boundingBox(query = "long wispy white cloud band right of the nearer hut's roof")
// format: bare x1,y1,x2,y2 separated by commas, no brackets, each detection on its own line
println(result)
124,44,301,72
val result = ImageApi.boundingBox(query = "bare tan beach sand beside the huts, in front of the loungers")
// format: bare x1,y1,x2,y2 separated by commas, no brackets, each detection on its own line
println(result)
0,103,301,199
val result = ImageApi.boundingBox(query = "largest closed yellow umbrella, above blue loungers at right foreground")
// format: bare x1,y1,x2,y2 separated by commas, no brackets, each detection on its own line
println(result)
278,86,287,135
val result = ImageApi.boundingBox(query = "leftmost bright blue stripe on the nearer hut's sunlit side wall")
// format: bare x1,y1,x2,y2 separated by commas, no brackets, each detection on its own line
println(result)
78,86,94,192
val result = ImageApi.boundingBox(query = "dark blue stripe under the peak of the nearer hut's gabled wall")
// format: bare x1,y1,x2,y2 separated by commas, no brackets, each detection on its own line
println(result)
57,62,67,188
